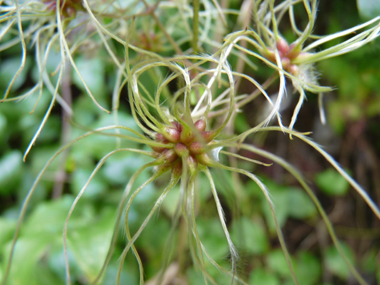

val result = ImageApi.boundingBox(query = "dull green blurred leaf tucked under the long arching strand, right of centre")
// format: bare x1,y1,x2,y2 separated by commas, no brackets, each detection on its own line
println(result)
287,188,317,219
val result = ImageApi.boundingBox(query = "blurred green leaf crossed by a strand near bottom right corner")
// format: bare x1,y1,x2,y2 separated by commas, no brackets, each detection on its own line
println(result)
324,243,354,280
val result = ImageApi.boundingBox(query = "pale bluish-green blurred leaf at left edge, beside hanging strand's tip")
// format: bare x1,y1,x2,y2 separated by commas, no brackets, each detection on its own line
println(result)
0,150,23,195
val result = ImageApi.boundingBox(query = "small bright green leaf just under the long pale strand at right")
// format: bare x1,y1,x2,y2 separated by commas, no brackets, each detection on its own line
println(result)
315,168,350,196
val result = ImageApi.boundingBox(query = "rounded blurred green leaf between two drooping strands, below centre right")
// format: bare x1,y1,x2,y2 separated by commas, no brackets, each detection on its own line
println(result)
231,217,269,254
